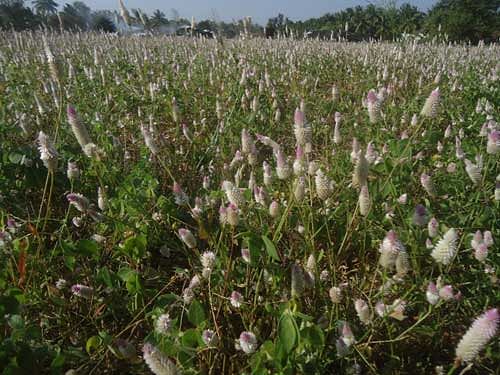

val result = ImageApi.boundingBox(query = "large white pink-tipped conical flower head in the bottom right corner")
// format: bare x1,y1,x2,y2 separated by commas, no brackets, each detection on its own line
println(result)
455,309,500,362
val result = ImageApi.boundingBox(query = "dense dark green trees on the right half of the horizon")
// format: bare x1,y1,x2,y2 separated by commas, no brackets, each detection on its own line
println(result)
266,0,500,43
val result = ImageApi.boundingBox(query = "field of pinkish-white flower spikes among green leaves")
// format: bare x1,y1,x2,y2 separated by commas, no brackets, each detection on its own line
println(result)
0,32,500,375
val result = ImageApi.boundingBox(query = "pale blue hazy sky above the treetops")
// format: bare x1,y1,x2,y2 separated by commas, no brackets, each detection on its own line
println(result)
56,0,436,24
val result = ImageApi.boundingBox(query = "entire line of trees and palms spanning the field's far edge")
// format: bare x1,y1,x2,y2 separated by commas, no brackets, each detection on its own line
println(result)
0,0,500,43
